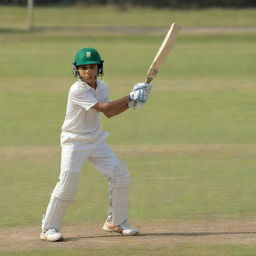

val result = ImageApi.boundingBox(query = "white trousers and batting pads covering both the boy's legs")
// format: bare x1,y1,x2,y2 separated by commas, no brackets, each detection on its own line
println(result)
42,140,129,231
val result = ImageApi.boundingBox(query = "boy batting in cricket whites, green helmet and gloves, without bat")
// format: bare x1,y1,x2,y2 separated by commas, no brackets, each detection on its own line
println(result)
40,48,151,242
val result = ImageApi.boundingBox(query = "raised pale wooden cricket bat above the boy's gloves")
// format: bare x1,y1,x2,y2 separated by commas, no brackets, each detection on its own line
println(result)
146,23,181,83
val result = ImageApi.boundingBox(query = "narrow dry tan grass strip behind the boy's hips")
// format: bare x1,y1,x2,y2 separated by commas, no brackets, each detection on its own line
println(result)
0,144,256,159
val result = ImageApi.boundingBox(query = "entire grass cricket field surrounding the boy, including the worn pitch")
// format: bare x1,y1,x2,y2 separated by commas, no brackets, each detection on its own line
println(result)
0,7,256,256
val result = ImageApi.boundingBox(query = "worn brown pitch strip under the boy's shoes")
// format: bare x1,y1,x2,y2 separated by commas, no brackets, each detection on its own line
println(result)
0,219,256,251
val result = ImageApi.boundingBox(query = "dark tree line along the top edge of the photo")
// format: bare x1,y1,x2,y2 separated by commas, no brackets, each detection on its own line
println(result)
0,0,256,9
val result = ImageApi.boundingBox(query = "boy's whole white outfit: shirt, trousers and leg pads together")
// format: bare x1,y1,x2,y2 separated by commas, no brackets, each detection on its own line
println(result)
42,80,129,231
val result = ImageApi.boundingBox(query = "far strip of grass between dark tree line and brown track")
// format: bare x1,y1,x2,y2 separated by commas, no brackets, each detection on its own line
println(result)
0,6,256,29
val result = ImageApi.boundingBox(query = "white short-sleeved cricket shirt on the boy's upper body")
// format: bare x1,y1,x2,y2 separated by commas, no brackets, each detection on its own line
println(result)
61,80,109,143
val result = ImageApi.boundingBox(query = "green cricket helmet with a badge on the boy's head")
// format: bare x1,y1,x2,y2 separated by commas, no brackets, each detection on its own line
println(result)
73,47,104,75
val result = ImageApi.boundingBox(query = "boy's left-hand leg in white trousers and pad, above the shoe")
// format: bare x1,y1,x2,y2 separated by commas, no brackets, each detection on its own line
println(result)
42,147,89,240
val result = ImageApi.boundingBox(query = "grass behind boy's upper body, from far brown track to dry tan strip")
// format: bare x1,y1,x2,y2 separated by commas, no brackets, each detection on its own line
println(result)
0,34,256,146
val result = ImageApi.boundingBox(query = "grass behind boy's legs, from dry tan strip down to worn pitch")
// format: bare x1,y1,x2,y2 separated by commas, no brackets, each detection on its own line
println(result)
0,145,256,227
